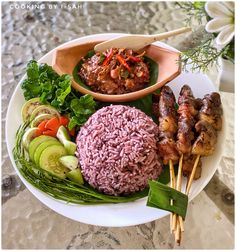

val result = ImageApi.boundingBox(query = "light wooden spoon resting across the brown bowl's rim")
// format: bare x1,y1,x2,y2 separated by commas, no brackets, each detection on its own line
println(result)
94,27,191,52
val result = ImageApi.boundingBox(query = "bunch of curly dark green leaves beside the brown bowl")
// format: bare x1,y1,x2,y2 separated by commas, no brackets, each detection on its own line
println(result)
21,60,96,129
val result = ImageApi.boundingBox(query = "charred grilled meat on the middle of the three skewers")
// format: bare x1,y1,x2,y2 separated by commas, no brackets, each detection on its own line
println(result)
176,85,198,154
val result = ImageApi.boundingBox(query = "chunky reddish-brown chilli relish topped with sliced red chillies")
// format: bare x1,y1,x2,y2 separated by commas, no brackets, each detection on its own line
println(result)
77,48,150,94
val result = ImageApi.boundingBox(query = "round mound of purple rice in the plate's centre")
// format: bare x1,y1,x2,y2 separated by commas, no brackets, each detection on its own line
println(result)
76,105,162,195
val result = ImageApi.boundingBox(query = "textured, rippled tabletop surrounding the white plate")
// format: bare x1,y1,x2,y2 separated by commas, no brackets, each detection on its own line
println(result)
2,2,234,249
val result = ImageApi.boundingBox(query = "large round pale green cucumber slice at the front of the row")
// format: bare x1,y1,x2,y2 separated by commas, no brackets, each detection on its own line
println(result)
39,145,69,179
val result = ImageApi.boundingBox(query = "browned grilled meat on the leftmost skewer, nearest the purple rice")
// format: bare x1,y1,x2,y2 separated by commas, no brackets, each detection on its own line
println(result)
158,86,179,164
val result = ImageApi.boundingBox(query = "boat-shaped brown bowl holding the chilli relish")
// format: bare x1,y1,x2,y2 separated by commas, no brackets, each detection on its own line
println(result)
52,41,181,102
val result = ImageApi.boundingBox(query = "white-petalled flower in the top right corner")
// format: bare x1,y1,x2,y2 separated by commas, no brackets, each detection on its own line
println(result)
205,1,234,48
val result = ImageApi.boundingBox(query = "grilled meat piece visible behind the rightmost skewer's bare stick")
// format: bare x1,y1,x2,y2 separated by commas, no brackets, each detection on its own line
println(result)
183,154,202,180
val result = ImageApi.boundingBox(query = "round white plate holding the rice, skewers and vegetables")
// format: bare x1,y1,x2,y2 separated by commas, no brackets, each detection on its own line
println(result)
6,33,226,227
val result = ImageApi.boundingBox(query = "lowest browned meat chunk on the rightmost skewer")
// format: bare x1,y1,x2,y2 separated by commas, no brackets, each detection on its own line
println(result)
192,120,217,156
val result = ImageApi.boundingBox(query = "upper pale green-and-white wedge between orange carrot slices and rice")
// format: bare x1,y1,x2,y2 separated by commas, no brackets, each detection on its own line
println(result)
57,126,76,155
